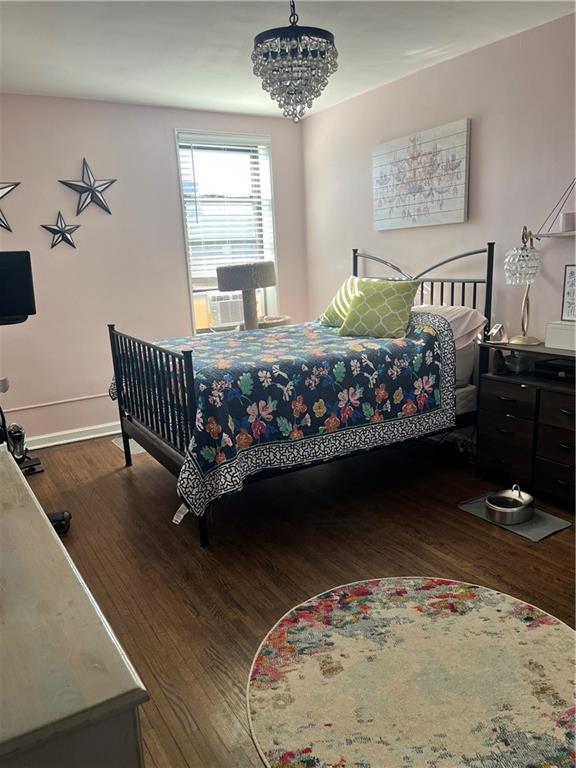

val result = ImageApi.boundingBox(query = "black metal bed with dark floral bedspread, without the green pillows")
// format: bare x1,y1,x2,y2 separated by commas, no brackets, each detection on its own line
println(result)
108,243,494,546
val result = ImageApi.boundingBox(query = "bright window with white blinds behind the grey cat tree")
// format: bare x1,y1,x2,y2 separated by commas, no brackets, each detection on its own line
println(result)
177,133,276,331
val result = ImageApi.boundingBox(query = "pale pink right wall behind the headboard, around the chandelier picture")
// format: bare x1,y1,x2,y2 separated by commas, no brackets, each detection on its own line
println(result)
303,16,574,338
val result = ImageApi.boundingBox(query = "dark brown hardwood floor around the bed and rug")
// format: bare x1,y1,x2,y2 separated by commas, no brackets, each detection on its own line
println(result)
30,439,574,768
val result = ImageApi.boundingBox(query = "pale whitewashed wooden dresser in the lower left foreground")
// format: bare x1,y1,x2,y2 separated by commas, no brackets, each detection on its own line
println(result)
0,445,148,768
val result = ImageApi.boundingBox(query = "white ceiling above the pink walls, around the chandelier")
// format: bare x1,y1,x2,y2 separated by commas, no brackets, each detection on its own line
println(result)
0,0,575,115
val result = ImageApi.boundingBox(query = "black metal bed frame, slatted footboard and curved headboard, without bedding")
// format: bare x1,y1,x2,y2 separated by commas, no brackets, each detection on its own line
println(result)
108,243,494,546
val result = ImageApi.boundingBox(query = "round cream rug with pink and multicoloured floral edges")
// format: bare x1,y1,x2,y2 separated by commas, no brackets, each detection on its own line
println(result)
248,578,575,768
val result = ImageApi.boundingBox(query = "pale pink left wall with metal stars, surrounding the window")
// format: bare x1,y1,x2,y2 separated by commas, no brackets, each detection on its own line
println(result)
0,95,307,435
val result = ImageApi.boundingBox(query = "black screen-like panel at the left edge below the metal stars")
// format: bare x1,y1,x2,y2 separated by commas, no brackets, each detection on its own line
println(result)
0,251,36,325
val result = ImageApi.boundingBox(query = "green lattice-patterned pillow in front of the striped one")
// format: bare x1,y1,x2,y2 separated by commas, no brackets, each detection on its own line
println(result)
339,279,420,339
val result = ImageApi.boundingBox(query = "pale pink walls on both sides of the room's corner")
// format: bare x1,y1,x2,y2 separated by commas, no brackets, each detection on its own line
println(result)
0,16,574,435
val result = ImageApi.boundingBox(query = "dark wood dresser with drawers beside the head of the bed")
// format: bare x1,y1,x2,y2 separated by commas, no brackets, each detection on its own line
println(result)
478,344,575,505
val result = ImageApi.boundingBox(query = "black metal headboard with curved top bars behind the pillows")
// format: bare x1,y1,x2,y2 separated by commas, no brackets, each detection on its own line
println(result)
352,243,495,333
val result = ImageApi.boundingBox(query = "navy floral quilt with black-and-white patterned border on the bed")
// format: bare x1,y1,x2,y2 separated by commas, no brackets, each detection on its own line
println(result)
151,313,456,515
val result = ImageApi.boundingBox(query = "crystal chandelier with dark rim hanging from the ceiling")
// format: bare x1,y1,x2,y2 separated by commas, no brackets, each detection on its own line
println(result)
252,0,338,123
